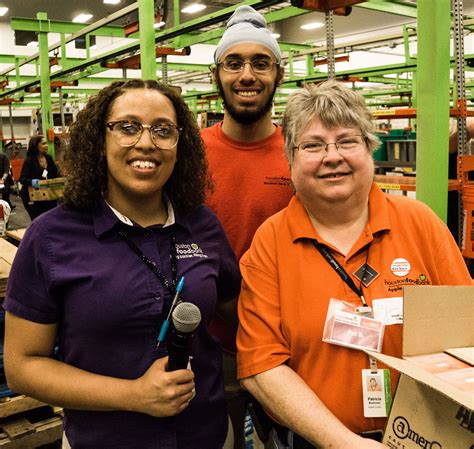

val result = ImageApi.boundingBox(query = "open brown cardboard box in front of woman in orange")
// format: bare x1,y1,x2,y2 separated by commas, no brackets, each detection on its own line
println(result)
367,286,474,449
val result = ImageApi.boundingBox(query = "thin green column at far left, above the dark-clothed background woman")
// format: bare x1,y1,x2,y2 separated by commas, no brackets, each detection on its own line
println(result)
36,12,55,158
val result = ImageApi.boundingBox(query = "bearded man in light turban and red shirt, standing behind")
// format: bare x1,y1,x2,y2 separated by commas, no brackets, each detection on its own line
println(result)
201,6,293,449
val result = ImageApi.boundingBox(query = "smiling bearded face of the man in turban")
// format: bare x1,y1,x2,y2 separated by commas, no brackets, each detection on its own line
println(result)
214,42,282,124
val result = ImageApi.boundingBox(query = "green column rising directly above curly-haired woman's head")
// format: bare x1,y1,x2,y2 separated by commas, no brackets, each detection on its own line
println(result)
138,0,156,80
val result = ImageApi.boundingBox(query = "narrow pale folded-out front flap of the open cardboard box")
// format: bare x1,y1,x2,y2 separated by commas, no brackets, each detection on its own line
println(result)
365,351,474,410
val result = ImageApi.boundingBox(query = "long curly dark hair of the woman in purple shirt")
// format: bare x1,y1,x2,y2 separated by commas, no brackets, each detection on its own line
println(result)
64,79,212,213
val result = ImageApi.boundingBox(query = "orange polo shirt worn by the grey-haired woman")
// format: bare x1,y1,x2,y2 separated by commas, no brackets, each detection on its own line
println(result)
237,184,472,432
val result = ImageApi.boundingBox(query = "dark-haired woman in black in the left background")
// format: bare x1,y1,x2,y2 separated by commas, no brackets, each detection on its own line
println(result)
19,135,60,220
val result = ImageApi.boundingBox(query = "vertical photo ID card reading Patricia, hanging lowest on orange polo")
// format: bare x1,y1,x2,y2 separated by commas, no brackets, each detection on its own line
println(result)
362,369,392,418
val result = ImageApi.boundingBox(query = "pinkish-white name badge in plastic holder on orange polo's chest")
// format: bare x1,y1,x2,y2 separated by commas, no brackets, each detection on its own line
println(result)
323,298,385,352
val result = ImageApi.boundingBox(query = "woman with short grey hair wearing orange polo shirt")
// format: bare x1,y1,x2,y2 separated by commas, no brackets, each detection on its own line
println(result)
237,81,472,449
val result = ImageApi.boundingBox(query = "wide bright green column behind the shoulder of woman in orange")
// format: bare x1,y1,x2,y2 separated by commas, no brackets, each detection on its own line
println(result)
416,0,451,222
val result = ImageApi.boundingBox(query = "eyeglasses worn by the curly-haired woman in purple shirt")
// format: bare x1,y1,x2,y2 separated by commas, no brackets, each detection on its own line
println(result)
106,120,182,150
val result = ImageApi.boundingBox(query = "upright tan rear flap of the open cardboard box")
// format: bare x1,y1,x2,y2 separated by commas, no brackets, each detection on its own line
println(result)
403,286,474,356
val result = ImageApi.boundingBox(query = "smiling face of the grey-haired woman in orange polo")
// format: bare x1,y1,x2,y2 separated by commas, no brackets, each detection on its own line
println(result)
291,119,374,206
